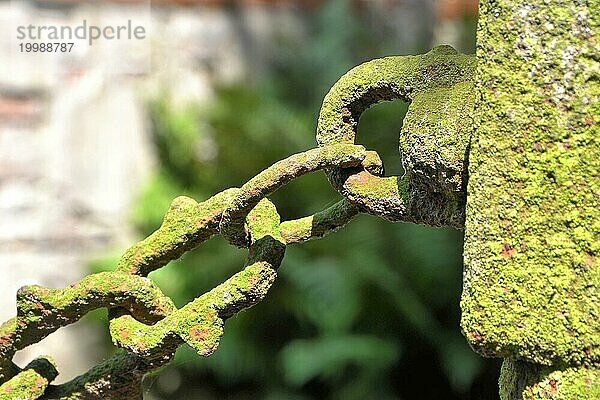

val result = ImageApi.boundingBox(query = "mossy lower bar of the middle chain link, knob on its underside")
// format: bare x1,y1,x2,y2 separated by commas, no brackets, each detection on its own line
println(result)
110,199,285,360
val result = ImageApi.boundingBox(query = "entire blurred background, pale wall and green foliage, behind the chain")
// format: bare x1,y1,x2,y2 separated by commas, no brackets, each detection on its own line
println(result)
0,0,498,399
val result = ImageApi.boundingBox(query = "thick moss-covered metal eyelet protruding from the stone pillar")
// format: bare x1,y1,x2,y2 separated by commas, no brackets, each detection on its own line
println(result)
317,46,475,228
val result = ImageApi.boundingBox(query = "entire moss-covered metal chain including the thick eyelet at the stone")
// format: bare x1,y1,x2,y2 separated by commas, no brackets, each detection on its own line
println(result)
0,46,474,400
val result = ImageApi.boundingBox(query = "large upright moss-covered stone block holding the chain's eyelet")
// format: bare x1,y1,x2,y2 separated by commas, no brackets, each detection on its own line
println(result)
461,0,600,372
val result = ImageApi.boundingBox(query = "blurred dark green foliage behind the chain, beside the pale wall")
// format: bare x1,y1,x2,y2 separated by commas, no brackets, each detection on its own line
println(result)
91,2,498,399
